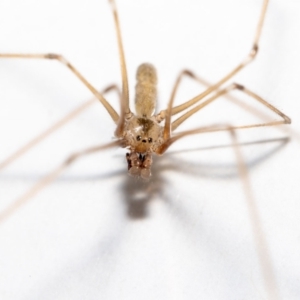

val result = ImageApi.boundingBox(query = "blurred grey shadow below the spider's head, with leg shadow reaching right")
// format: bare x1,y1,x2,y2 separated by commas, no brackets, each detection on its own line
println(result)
120,138,289,219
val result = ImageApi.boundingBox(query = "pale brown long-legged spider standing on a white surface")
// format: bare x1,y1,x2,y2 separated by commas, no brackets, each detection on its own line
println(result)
0,0,290,298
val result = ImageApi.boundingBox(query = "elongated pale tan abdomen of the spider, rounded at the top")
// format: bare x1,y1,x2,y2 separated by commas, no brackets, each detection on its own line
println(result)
135,63,157,118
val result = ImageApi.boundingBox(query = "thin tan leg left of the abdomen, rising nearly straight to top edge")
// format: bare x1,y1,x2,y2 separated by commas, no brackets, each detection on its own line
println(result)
109,0,132,137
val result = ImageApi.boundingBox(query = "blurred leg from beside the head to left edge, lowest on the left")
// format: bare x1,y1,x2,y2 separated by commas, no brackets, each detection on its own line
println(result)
0,141,120,223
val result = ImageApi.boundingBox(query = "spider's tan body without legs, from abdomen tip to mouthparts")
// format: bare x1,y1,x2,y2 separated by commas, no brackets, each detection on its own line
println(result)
122,64,163,179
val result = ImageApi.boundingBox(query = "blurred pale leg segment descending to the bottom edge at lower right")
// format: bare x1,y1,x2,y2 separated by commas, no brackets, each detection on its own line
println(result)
229,129,279,300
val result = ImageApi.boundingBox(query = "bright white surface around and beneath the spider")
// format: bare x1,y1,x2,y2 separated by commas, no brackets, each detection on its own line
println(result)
0,0,300,299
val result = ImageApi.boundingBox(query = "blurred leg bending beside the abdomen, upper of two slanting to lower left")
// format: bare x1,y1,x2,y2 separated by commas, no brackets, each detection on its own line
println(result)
0,85,120,170
